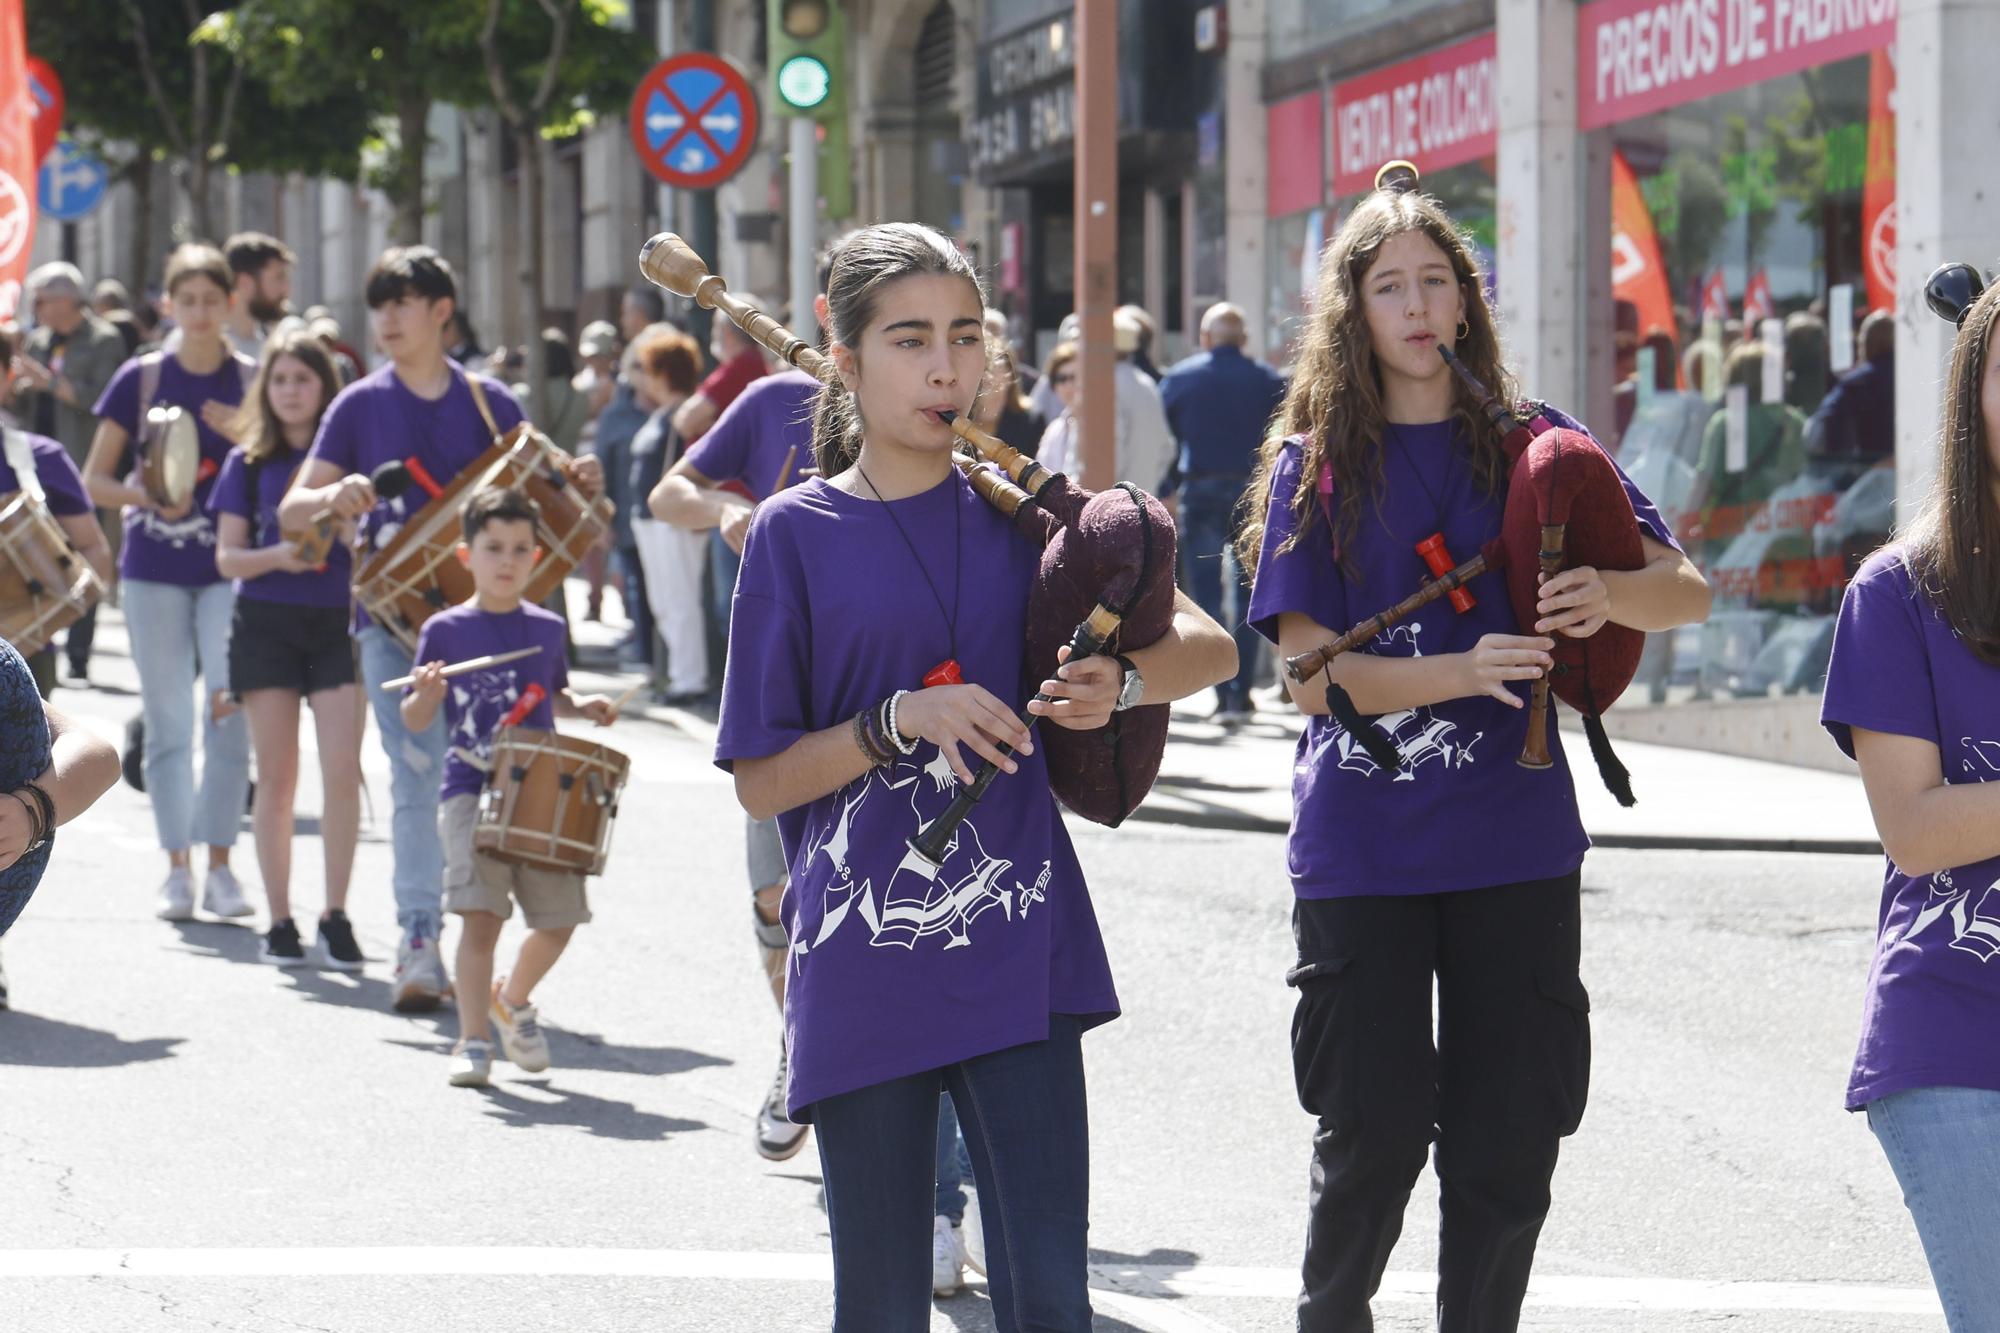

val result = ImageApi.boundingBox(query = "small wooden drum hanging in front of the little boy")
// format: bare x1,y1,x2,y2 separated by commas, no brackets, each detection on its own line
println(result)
472,727,632,875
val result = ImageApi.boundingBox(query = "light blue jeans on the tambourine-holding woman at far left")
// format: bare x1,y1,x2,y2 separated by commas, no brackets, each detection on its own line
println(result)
124,578,250,853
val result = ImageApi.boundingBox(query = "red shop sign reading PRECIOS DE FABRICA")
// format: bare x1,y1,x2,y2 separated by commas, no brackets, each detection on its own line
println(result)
1576,0,1896,130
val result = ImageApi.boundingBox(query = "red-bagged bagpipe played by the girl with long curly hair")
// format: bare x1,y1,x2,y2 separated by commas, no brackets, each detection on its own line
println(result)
1284,162,1646,805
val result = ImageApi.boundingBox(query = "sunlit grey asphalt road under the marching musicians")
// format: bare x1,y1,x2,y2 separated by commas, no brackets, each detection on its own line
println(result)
0,616,1942,1333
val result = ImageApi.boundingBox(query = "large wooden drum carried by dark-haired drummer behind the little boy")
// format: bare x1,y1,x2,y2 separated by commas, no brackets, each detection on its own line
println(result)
354,422,612,652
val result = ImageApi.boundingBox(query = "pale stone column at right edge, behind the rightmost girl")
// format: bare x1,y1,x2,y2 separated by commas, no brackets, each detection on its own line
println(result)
1896,0,2000,528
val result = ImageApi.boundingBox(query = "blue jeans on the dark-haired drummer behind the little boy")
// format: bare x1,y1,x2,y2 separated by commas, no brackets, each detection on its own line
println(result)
360,624,444,939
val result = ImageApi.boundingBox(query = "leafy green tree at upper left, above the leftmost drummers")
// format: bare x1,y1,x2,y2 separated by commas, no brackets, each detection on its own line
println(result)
28,0,368,280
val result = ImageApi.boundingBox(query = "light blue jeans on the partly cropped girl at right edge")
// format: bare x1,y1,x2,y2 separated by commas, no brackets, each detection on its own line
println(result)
1868,1087,2000,1333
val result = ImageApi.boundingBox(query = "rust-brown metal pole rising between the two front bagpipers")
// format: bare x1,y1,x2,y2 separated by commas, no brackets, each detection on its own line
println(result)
1074,0,1120,490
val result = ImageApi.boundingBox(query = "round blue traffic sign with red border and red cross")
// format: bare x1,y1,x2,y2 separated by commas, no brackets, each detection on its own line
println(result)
632,50,756,190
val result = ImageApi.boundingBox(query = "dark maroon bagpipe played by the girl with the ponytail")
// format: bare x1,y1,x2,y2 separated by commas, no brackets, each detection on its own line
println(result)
638,232,1176,840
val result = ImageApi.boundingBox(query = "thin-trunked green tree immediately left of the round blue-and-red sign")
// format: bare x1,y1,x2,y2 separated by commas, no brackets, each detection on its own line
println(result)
478,0,654,408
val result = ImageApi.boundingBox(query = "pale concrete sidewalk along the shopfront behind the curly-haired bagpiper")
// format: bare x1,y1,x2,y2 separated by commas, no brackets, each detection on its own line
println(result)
1134,691,1882,857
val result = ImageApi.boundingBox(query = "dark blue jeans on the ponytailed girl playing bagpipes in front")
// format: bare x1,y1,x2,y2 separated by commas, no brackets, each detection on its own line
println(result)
812,1015,1090,1333
